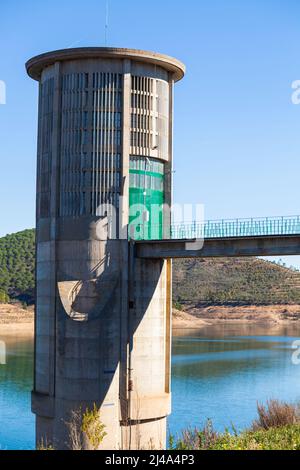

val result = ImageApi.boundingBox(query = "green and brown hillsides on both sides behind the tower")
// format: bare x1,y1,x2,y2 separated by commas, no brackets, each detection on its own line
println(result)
0,229,300,308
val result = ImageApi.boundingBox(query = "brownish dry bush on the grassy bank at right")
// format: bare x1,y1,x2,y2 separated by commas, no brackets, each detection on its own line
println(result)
252,400,300,431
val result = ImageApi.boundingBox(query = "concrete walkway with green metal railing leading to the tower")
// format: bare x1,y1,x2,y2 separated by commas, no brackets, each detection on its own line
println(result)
135,215,300,258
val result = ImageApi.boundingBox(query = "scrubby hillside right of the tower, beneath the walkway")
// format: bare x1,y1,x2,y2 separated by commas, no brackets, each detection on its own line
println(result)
173,258,300,306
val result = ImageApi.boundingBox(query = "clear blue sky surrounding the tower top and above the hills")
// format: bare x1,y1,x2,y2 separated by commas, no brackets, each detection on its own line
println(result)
0,0,300,264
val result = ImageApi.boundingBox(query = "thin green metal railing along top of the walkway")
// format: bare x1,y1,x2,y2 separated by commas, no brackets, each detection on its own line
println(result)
137,215,300,240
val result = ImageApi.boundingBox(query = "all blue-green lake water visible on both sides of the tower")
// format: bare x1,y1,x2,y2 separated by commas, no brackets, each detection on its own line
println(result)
0,324,300,449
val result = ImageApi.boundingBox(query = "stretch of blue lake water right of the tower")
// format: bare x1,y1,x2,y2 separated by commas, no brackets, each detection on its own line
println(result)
169,323,300,433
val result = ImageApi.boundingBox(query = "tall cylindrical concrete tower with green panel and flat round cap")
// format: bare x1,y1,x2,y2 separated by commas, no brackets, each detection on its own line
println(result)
26,47,184,449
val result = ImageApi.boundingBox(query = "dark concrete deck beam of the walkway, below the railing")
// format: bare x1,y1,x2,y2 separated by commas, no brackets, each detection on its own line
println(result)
135,235,300,259
